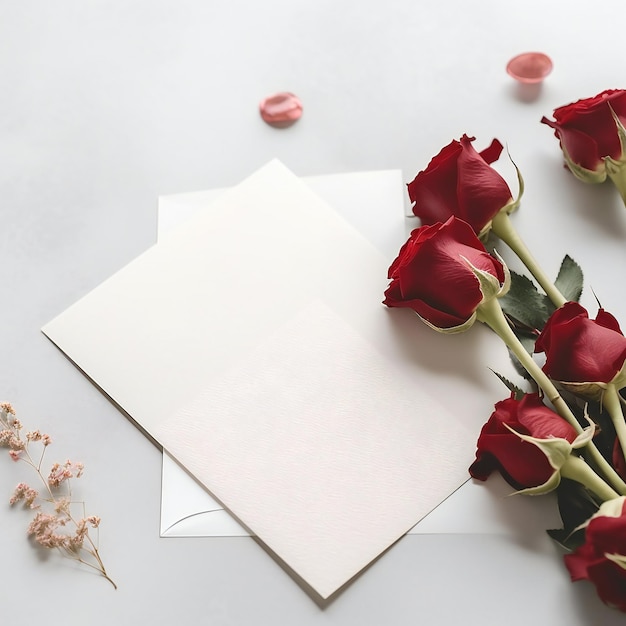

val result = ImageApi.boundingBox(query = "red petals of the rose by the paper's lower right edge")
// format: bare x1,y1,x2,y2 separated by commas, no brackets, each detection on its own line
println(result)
469,393,577,489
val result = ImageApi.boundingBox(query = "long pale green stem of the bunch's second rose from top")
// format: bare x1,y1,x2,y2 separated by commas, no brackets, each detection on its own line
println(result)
476,298,626,495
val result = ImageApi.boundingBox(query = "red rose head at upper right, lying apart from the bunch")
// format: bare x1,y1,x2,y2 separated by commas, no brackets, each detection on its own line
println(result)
541,89,626,182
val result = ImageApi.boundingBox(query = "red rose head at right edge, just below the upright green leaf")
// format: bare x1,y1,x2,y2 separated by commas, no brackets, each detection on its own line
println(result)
535,302,626,399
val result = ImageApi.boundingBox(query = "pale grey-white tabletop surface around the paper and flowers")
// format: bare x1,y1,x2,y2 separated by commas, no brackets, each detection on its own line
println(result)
0,0,626,626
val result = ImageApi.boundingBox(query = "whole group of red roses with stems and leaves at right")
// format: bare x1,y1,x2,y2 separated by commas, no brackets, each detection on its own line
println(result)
384,90,626,611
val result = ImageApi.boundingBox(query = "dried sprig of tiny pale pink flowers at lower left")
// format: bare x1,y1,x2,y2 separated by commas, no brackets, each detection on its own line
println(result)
0,402,117,589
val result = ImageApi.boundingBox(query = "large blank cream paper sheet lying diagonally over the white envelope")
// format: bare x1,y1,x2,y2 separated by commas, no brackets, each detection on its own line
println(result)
43,161,516,598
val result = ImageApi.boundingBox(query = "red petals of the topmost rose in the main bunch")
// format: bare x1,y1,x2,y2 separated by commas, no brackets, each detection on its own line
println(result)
407,135,513,234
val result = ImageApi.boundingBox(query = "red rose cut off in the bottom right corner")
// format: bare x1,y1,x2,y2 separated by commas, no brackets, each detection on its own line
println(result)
564,497,626,611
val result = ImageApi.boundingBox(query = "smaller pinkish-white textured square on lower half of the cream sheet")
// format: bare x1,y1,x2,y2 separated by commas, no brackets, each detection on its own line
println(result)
155,302,466,597
